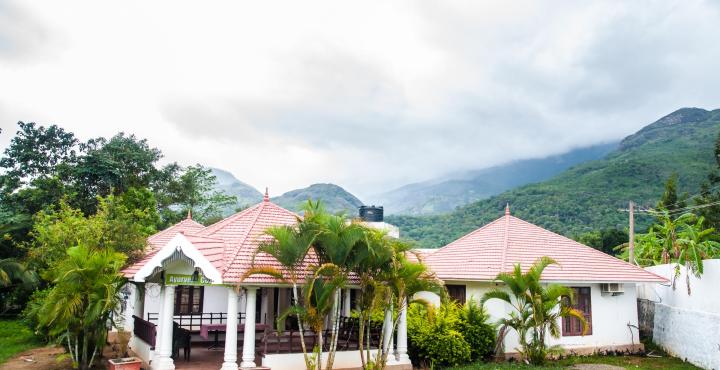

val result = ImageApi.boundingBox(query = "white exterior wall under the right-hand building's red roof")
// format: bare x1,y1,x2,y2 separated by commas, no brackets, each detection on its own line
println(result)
420,282,639,353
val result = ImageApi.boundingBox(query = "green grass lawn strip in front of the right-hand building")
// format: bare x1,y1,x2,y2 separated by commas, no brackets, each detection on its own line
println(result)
452,355,700,370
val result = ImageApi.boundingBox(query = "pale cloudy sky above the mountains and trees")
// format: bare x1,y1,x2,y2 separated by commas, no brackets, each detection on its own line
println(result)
0,0,720,198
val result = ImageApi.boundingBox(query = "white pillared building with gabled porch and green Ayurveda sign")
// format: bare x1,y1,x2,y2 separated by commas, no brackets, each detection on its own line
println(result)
123,194,411,370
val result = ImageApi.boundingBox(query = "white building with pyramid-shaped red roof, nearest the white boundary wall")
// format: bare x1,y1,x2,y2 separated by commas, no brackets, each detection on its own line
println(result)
422,209,667,356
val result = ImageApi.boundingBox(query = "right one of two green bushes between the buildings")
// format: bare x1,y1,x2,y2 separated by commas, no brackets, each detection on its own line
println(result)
458,299,496,361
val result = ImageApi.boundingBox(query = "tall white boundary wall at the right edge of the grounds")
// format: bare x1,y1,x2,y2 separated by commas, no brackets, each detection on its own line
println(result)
638,259,720,369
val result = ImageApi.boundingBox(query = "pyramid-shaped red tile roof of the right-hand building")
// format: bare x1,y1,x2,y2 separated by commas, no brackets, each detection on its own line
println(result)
425,209,666,282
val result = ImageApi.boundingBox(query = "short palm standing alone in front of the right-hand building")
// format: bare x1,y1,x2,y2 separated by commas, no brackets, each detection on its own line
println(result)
481,257,587,364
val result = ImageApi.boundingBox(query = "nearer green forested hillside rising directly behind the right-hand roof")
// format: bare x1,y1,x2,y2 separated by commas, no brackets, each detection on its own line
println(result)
387,108,720,247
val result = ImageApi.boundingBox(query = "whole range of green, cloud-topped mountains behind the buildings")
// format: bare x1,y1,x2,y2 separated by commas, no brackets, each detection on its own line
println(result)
214,108,720,248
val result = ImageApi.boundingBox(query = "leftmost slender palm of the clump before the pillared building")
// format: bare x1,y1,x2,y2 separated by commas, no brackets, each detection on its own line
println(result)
240,219,317,368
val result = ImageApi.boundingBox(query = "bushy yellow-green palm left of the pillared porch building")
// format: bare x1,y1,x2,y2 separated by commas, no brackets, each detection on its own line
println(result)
34,245,126,370
